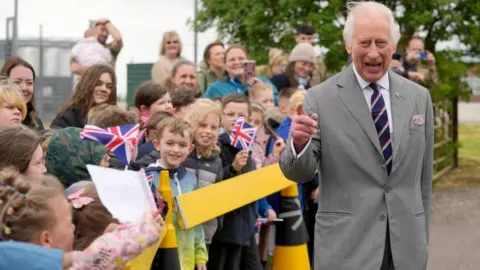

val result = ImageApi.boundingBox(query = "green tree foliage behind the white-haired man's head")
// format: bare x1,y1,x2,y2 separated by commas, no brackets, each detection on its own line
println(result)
195,0,480,98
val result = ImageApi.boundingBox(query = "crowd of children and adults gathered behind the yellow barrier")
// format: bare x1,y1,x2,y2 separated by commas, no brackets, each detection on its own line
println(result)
0,1,438,270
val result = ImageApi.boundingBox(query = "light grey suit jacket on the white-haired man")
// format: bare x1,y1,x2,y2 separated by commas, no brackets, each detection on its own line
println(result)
280,66,434,270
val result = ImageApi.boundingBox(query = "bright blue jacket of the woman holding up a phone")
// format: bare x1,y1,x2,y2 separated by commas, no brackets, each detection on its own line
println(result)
203,76,278,106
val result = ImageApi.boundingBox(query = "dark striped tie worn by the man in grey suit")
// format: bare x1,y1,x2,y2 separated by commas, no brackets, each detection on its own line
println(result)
370,83,393,175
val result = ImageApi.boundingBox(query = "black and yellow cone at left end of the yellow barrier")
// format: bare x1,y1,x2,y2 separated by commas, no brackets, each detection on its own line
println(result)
152,171,181,270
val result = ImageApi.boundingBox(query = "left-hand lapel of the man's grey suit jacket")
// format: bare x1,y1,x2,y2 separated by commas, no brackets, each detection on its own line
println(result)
337,65,383,156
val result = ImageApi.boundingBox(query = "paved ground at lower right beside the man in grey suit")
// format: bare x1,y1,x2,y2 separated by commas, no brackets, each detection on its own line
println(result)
428,188,480,270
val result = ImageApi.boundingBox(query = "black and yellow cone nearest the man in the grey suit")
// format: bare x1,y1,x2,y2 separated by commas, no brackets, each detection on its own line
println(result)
272,184,311,270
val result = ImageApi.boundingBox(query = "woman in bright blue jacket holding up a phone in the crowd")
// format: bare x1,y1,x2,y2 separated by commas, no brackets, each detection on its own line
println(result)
204,45,278,105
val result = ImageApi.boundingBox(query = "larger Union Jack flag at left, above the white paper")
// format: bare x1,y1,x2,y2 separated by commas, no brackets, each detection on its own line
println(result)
80,124,140,165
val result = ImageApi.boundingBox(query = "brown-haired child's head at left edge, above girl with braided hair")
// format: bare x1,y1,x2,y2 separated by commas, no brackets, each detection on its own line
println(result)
0,126,47,179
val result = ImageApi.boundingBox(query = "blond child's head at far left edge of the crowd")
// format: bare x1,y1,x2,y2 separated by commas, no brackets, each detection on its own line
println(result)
0,82,27,126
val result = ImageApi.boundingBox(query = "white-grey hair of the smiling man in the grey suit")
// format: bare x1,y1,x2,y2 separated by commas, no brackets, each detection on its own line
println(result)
343,1,400,45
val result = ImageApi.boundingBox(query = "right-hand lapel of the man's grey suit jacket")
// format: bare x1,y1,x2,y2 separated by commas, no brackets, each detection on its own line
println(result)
388,70,408,164
